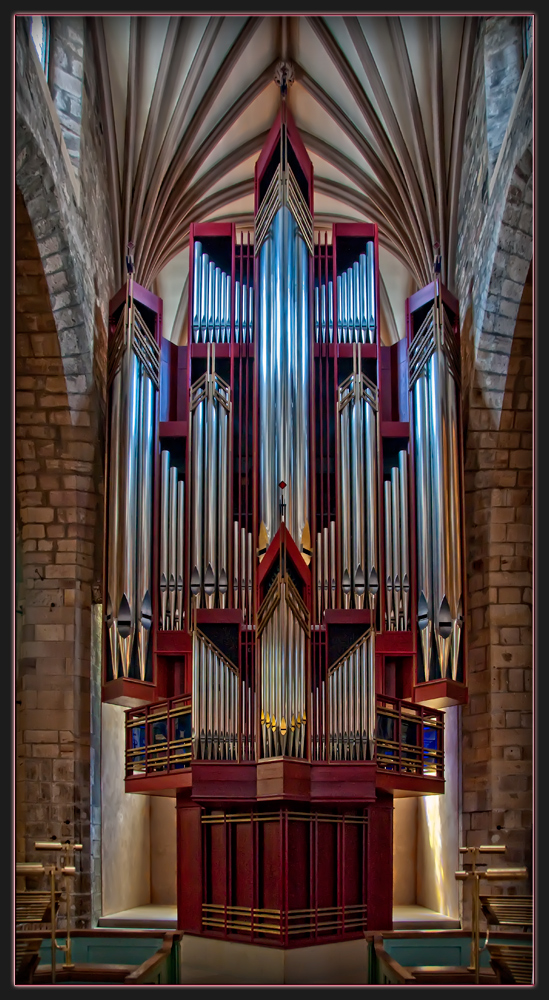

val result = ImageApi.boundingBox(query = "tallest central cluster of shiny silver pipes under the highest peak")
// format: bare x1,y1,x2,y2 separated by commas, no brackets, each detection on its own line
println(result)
259,206,310,547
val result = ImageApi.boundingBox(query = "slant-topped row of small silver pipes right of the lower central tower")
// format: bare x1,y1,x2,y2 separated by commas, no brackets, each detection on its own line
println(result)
328,630,376,760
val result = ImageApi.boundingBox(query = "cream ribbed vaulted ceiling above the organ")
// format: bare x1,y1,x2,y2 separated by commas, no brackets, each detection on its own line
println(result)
89,15,477,343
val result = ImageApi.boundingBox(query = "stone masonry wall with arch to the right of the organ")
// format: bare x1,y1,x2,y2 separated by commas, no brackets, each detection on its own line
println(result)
456,19,533,924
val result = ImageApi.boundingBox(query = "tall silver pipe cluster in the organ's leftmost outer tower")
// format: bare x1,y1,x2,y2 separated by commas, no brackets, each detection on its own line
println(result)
105,274,160,680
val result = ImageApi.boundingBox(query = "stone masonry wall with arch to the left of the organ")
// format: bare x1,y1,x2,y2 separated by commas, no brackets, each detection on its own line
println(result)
15,17,116,927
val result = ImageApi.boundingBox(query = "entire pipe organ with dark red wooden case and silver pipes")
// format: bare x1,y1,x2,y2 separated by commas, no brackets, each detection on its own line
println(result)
103,102,467,947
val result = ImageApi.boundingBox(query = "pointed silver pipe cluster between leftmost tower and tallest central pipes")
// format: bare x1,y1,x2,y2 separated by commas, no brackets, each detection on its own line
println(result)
190,347,231,608
